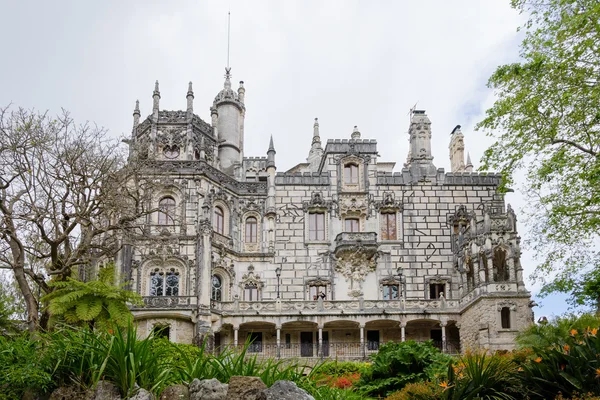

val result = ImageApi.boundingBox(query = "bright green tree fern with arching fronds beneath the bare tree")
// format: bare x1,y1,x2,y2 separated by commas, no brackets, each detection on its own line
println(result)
42,265,142,326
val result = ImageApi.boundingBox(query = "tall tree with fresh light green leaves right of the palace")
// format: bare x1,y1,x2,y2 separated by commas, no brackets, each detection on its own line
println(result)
477,0,600,303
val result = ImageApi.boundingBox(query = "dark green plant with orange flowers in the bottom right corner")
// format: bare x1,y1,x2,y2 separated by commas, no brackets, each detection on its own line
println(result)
522,328,600,399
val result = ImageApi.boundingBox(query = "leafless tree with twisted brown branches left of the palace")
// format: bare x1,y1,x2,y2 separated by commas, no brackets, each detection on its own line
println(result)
0,107,153,331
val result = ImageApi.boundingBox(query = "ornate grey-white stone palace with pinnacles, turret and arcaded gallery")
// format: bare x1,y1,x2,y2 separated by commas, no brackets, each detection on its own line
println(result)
117,70,533,358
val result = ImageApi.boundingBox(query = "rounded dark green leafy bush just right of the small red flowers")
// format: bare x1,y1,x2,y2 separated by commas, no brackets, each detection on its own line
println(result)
359,340,452,396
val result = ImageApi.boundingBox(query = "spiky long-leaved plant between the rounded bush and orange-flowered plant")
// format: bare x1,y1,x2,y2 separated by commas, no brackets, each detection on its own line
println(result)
440,352,523,400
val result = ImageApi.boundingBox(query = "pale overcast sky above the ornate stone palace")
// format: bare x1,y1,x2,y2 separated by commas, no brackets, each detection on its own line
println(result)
0,0,566,317
